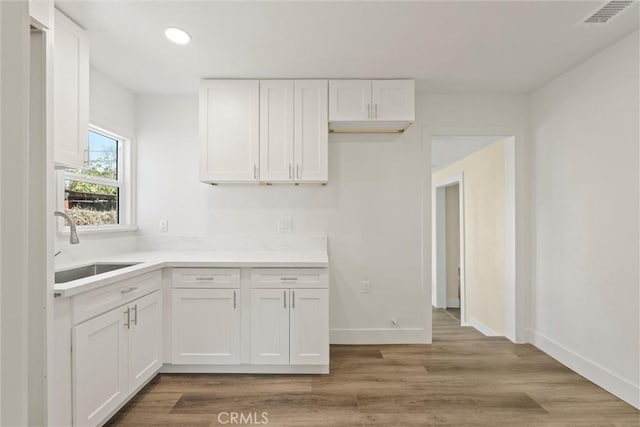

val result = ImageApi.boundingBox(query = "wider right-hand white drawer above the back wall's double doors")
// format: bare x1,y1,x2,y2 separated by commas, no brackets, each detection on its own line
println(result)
251,268,329,288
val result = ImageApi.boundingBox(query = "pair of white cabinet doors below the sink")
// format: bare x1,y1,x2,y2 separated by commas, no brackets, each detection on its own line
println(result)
72,291,162,426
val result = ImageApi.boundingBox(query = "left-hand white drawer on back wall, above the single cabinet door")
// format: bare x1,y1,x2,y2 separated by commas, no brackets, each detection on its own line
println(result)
171,268,240,289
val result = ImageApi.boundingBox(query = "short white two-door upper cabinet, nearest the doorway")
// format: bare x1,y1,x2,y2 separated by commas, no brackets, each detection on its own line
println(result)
329,80,415,133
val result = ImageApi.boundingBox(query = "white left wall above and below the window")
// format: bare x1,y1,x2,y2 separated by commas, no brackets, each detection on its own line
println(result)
55,66,138,267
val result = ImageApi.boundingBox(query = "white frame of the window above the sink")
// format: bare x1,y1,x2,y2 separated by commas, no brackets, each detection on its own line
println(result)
56,124,138,234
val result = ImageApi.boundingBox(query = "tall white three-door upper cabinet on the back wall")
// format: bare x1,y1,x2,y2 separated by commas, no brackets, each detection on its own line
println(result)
200,80,328,184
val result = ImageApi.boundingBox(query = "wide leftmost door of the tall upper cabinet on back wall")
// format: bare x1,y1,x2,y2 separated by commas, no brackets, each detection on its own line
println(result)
200,80,260,182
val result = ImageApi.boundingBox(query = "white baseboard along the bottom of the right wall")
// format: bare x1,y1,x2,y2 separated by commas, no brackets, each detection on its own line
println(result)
533,331,640,409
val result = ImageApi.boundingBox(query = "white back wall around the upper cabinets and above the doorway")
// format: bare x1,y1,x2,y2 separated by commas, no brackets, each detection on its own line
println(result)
136,94,528,343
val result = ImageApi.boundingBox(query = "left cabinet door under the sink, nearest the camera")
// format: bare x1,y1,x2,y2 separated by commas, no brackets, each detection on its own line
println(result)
72,307,129,426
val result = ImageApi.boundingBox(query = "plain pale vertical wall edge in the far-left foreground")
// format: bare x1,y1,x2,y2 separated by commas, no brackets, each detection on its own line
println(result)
0,1,30,426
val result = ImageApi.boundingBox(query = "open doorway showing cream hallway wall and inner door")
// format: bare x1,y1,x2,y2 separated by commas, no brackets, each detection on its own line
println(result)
432,136,515,339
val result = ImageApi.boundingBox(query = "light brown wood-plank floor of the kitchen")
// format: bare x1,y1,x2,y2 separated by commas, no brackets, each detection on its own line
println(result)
110,310,640,427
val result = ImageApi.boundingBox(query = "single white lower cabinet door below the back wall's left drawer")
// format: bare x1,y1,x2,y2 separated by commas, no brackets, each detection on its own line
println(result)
172,289,240,365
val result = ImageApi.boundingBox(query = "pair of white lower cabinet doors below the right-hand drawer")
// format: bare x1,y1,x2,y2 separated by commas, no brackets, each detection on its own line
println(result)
251,289,329,365
